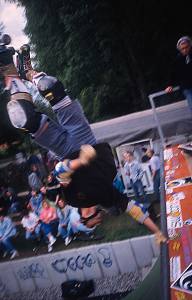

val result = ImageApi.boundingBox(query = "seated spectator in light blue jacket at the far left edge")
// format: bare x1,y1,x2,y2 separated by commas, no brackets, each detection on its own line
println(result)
0,212,19,259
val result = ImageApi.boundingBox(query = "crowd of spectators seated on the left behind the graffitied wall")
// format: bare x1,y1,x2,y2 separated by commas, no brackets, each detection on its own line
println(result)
0,155,102,259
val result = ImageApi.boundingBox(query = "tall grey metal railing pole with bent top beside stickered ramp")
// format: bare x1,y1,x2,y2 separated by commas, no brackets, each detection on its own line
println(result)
149,87,178,300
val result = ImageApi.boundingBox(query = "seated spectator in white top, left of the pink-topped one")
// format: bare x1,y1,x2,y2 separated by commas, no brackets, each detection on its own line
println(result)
21,209,41,251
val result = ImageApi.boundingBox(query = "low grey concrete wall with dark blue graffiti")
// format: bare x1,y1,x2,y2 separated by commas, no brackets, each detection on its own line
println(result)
0,235,159,299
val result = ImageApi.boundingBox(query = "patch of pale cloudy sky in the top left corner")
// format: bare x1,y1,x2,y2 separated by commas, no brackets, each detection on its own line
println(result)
0,0,28,49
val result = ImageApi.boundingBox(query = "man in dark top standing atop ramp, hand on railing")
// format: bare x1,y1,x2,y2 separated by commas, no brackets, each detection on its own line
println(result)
165,36,192,114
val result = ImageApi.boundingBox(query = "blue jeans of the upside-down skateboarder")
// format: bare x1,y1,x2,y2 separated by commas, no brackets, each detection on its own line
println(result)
33,101,96,159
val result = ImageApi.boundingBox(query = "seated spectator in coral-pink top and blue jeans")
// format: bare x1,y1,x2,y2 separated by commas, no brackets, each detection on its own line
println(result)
39,200,58,252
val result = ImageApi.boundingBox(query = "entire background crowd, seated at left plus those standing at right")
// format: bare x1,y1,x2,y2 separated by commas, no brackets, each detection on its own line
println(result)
0,146,159,259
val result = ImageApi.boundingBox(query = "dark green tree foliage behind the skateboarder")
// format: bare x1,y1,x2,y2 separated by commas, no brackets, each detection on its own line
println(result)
5,0,192,121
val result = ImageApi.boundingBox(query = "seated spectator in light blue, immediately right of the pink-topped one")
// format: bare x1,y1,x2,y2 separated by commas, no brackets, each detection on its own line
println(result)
57,198,72,246
